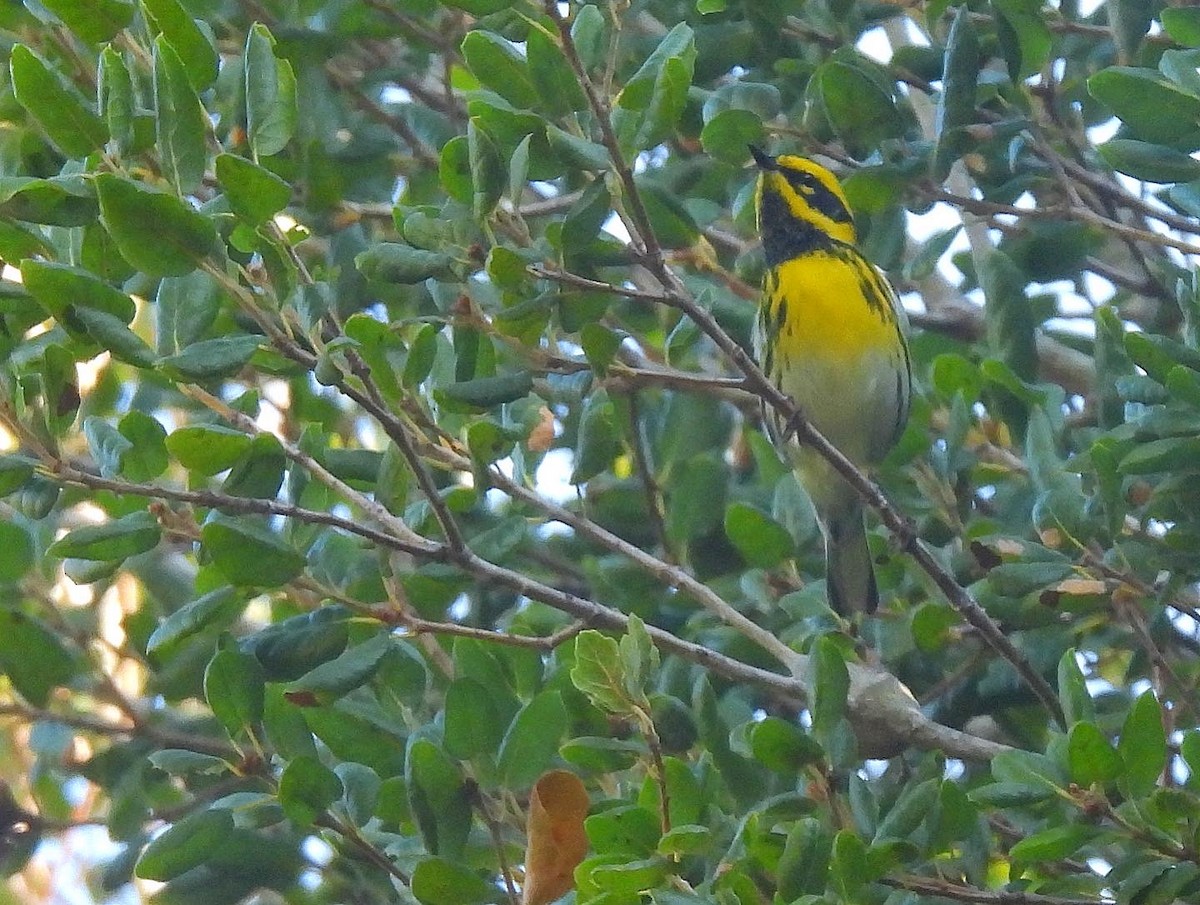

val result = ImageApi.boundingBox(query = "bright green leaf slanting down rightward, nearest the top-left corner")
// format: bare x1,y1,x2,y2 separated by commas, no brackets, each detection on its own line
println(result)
8,44,108,157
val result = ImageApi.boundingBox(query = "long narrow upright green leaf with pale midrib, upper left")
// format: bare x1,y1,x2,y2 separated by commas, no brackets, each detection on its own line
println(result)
154,36,209,194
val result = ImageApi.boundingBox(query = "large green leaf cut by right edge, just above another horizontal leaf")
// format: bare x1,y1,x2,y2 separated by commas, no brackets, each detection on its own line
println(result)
1087,66,1200,154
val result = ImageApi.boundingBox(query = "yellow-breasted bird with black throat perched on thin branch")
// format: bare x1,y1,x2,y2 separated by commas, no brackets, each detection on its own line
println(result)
750,145,912,618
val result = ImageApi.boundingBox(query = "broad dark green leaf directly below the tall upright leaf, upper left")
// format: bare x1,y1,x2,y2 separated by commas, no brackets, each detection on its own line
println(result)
96,173,217,276
